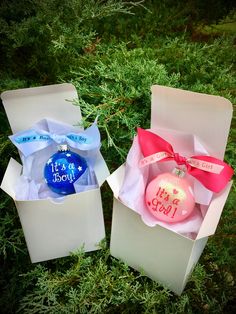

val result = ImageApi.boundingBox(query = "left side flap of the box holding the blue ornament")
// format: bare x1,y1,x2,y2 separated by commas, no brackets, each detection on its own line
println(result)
1,158,22,199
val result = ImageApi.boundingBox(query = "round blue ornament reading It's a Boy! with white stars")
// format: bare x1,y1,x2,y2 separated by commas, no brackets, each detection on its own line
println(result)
44,145,87,195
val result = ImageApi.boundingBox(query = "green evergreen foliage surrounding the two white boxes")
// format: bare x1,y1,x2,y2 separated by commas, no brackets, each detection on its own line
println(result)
0,0,236,314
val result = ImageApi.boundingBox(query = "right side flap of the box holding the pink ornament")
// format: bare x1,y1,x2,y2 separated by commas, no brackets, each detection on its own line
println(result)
196,181,233,239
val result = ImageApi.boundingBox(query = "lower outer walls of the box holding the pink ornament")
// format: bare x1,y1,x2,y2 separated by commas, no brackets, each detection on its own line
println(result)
110,199,207,294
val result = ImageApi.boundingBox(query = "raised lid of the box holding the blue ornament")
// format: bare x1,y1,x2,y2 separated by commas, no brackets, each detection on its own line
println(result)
1,83,81,133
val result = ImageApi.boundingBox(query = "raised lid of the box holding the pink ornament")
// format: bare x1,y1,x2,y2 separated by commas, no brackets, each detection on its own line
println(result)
151,85,233,159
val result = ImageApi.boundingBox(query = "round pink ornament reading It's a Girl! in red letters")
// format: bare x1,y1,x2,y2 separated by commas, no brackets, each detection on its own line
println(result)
145,169,195,222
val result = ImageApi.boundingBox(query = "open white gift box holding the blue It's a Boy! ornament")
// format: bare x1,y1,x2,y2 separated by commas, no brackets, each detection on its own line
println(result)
1,84,109,263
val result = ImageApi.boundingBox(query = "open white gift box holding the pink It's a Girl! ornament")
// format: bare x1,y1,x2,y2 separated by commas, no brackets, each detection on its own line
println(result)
107,85,232,295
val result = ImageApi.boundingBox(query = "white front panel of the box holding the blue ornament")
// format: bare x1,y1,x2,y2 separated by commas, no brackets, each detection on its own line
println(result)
17,189,105,262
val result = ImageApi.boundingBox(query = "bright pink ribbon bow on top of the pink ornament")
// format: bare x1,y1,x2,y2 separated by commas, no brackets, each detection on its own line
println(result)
138,128,234,193
